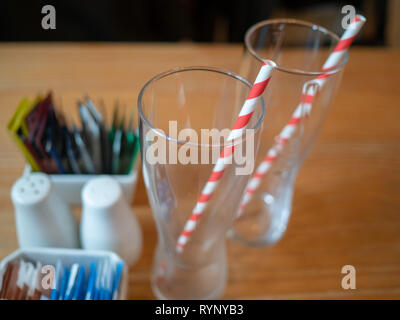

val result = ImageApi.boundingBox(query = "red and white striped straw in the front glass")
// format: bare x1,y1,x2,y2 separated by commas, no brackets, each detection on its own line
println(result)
176,60,275,252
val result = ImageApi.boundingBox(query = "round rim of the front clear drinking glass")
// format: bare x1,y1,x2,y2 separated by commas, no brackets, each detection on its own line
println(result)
137,66,265,147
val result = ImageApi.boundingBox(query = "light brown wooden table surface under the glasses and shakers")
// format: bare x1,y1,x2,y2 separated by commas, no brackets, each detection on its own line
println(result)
0,44,400,299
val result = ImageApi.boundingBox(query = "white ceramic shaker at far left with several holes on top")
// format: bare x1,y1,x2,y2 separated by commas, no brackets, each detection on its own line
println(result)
11,173,79,248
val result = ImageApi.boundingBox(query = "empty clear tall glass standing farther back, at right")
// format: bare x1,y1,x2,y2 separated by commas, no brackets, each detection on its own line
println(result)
229,19,347,246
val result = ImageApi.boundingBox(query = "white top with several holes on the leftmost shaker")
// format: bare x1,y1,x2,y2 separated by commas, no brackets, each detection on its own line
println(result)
11,172,52,205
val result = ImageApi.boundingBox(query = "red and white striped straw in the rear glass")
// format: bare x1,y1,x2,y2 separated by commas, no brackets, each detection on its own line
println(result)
238,15,366,217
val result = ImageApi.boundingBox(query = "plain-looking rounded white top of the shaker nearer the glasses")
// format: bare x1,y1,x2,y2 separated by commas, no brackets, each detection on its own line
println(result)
82,176,122,208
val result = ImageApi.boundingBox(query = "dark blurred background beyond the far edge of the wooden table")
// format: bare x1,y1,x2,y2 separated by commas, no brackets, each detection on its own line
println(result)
0,0,400,46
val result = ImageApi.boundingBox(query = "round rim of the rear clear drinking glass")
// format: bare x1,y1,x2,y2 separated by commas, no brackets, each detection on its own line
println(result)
244,18,349,76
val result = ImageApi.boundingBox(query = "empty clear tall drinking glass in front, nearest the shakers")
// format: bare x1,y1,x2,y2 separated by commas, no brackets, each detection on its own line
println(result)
138,67,265,299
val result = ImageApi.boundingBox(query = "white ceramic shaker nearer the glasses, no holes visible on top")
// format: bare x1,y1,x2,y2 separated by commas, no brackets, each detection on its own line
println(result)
80,176,142,265
